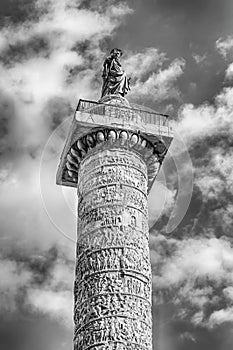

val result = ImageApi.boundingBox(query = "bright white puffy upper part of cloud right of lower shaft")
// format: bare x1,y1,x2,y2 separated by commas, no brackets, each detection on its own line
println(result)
152,238,233,287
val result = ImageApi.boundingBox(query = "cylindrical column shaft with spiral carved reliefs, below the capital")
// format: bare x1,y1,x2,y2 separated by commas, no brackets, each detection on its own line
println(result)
73,141,152,350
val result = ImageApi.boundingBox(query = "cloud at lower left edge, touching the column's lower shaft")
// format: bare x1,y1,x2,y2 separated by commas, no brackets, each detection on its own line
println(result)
0,250,73,326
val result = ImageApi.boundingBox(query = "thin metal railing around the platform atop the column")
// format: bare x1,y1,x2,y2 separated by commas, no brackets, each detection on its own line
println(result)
76,100,168,127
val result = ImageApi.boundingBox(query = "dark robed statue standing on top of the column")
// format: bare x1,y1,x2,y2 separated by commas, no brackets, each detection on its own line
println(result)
101,48,130,98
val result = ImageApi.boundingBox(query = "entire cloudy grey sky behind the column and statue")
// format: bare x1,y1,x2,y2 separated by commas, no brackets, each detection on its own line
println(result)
0,0,233,350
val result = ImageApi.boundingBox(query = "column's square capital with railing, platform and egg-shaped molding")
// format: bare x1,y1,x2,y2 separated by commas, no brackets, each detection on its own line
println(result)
57,95,173,191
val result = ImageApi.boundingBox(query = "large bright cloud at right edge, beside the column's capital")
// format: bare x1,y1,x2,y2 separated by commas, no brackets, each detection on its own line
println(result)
175,79,233,237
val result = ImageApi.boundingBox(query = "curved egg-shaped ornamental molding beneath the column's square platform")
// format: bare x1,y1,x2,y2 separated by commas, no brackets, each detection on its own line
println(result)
63,128,167,193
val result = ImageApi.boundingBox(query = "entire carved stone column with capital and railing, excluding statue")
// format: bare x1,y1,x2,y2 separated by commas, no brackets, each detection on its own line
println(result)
57,95,172,350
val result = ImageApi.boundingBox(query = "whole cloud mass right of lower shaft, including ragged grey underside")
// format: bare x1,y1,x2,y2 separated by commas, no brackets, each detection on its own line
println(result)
151,235,233,327
